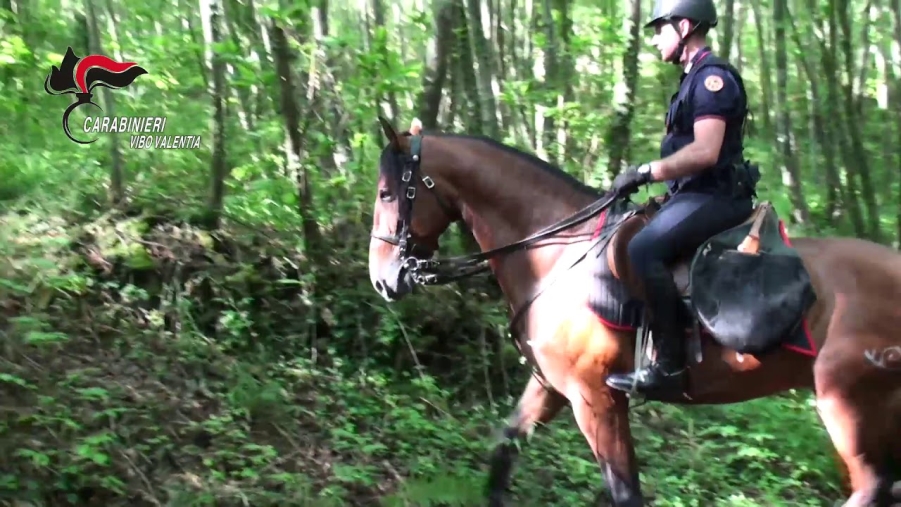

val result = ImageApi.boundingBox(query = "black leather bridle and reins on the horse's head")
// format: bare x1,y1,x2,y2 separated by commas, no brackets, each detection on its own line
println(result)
370,133,620,285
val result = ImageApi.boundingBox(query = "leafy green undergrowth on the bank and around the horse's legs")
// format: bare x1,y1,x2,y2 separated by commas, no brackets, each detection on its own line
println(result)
0,204,838,507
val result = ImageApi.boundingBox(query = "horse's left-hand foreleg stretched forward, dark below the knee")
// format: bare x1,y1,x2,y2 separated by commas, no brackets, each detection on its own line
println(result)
488,376,567,507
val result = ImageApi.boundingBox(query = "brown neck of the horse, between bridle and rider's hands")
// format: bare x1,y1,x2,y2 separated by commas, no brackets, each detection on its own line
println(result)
423,138,597,307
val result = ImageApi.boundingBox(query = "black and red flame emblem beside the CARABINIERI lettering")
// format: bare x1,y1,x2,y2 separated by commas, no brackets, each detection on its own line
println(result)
44,46,146,144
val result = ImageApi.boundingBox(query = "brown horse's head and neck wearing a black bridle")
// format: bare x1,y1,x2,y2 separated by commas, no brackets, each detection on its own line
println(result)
369,117,605,306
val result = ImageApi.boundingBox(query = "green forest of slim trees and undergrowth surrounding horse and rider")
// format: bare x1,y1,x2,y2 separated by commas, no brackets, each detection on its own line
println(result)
0,0,901,507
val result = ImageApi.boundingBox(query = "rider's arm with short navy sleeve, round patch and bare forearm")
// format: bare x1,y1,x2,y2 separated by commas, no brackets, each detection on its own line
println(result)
651,67,741,181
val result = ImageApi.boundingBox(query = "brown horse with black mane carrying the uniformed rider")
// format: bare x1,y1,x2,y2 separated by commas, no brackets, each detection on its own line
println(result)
369,118,901,507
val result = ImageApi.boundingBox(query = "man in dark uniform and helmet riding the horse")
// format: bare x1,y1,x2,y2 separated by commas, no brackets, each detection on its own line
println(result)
607,0,759,393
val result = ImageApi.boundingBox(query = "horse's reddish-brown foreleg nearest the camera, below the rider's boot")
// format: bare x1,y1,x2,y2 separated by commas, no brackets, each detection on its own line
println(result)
570,384,644,507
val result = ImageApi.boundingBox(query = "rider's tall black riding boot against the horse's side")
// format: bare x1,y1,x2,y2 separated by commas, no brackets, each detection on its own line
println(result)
607,269,686,394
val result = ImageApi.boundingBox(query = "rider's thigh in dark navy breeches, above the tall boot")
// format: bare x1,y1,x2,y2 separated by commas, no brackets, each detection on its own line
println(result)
628,192,753,279
